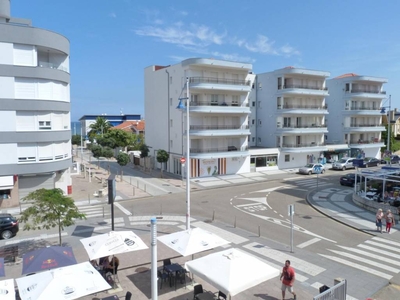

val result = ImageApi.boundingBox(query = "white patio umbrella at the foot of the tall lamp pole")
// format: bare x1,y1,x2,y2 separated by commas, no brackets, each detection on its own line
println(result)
157,227,230,256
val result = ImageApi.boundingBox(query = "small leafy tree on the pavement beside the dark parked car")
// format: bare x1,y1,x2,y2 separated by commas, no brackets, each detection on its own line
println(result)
19,189,86,246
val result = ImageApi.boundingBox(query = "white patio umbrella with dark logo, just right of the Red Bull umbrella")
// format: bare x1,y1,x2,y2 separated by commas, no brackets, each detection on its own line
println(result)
81,231,148,260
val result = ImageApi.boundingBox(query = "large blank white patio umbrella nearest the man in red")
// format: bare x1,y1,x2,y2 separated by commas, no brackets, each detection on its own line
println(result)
185,248,280,297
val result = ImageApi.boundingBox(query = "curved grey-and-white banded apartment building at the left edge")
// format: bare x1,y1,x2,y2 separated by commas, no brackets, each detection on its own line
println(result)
0,0,72,207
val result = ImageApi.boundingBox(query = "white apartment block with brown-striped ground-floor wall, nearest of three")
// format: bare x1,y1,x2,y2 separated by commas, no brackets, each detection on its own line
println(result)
145,58,255,178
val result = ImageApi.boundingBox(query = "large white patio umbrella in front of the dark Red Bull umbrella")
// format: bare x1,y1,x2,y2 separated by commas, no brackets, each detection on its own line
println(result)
15,262,111,300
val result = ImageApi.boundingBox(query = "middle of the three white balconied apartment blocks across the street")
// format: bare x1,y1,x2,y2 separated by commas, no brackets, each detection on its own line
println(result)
250,67,348,170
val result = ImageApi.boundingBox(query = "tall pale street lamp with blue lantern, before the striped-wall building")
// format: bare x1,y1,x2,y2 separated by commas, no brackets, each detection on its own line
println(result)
176,77,190,230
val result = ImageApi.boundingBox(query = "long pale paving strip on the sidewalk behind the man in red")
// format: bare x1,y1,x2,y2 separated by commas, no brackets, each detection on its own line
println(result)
243,243,326,276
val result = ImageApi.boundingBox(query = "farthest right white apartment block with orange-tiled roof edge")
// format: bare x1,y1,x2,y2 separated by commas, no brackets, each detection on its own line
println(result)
327,73,387,158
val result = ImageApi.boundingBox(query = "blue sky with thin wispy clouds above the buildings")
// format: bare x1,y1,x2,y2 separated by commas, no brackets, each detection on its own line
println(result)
11,0,400,121
